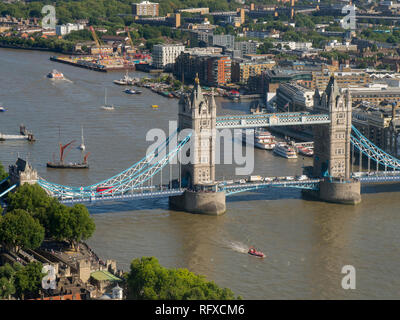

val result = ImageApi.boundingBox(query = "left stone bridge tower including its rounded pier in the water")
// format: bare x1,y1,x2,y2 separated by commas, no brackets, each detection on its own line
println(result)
170,76,226,215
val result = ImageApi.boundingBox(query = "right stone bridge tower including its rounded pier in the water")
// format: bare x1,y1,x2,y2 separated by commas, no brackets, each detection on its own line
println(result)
313,76,361,204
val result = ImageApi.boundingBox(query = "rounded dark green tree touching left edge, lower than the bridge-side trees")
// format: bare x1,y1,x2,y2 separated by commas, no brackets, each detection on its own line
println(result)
0,209,44,251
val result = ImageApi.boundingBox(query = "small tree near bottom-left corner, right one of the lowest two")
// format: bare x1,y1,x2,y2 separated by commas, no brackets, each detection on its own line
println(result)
14,262,45,299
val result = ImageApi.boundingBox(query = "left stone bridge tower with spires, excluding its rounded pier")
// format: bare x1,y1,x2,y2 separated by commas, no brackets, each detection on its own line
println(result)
178,76,217,187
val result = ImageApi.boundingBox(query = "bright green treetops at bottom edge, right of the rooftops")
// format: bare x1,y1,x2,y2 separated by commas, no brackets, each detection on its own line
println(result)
127,257,240,300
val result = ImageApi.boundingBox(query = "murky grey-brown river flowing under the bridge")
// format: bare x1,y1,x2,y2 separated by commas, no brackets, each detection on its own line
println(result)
0,49,400,299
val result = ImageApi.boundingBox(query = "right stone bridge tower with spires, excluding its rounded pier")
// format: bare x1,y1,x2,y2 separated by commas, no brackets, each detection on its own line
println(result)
313,76,352,179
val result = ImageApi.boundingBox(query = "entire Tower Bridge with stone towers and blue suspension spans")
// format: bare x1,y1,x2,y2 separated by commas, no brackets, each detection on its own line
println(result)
0,77,400,215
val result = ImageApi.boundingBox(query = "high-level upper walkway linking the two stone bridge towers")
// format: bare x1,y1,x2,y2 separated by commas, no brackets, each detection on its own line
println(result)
216,112,331,129
